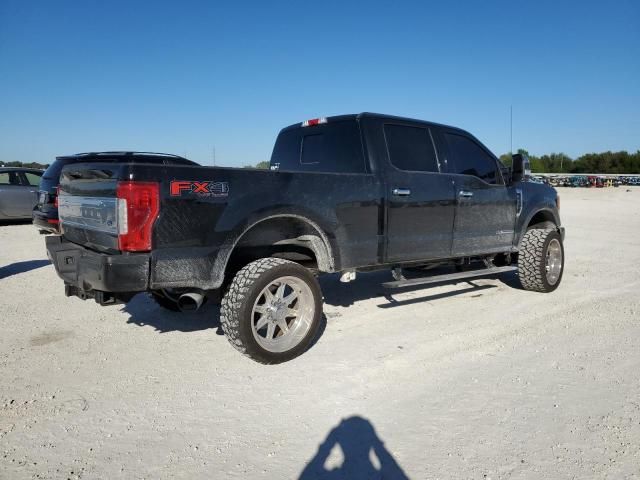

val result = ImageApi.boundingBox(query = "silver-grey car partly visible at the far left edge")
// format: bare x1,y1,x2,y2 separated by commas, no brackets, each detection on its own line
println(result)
0,167,42,220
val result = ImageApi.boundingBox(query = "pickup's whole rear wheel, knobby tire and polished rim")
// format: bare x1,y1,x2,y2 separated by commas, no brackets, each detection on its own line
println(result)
220,258,322,364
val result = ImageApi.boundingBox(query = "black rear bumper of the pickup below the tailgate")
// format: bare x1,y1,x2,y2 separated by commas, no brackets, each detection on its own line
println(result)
45,236,149,304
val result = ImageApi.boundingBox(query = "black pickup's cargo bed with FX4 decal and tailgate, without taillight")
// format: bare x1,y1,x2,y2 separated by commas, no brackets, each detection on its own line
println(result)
60,163,383,289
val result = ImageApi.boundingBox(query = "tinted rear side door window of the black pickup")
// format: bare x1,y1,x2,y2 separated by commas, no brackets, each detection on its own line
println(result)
384,124,438,172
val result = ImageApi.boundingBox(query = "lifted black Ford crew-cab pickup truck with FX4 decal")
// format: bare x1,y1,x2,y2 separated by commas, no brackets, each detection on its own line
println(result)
46,113,564,363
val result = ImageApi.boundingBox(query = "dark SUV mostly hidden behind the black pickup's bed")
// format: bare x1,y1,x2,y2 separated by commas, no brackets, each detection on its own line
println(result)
33,152,198,233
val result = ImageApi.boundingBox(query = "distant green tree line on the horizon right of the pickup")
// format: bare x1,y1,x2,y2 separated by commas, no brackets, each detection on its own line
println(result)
500,148,640,174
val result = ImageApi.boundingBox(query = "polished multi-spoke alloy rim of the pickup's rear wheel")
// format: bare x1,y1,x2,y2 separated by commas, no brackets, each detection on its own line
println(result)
251,277,315,353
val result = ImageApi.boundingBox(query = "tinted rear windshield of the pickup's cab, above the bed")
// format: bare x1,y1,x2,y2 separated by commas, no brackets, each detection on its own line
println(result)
271,120,366,173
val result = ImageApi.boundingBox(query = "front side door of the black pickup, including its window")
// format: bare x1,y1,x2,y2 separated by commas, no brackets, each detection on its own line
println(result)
443,131,516,256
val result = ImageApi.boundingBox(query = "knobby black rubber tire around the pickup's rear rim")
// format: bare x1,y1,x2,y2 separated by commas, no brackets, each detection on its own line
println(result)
220,258,322,364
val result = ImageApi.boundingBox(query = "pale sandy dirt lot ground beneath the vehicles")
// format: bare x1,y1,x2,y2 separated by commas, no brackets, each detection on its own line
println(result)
0,188,640,480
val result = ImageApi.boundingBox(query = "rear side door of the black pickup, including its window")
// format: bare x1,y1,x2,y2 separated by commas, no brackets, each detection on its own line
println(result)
381,121,455,262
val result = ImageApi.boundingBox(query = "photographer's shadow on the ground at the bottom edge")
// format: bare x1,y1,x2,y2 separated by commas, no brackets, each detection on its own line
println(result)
298,416,409,480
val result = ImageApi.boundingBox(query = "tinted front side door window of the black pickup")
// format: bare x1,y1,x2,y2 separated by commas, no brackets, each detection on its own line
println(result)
444,133,502,185
